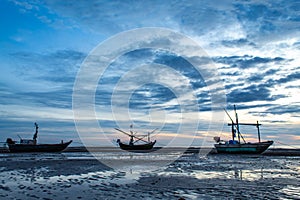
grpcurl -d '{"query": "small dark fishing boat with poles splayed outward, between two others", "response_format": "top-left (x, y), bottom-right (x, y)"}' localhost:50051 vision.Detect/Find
top-left (115, 125), bottom-right (156, 151)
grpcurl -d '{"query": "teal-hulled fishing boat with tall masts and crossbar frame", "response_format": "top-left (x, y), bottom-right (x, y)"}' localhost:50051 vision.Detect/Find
top-left (214, 105), bottom-right (273, 154)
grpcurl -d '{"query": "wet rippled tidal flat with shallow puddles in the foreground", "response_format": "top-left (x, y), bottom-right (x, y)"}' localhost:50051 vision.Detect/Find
top-left (0, 149), bottom-right (300, 200)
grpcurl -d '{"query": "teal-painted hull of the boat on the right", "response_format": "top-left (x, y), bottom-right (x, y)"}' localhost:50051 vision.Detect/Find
top-left (215, 141), bottom-right (273, 154)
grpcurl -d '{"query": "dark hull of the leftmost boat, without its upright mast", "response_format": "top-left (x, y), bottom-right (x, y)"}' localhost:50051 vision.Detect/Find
top-left (8, 140), bottom-right (72, 153)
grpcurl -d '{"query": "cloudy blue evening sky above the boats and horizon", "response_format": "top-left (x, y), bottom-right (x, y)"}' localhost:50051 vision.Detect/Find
top-left (0, 0), bottom-right (300, 147)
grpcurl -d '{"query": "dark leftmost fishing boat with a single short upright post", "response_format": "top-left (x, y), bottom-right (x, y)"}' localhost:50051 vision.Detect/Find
top-left (6, 123), bottom-right (72, 153)
